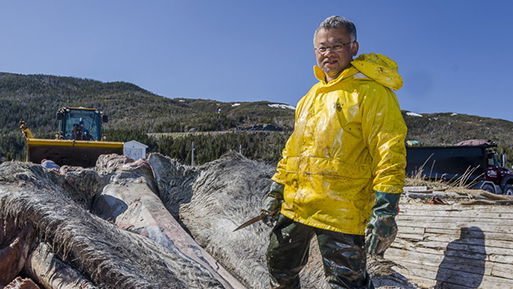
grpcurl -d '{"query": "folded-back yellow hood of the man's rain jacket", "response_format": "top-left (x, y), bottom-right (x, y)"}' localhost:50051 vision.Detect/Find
top-left (351, 53), bottom-right (403, 90)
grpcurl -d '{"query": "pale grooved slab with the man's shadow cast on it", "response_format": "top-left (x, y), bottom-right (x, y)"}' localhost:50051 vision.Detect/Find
top-left (385, 203), bottom-right (513, 289)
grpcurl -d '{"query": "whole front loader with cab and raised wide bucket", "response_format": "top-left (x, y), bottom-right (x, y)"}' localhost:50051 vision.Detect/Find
top-left (20, 107), bottom-right (123, 167)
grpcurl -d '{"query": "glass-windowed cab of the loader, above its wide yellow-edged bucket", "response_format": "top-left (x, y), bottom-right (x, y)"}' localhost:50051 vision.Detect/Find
top-left (56, 107), bottom-right (108, 141)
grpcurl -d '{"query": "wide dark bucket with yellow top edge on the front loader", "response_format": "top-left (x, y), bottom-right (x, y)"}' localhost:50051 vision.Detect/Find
top-left (27, 139), bottom-right (123, 168)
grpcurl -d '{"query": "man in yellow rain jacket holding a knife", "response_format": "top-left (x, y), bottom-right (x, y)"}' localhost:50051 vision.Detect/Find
top-left (262, 16), bottom-right (406, 288)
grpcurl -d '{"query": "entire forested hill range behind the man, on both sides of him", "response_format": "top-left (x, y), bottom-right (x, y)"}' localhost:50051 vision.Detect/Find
top-left (0, 73), bottom-right (513, 164)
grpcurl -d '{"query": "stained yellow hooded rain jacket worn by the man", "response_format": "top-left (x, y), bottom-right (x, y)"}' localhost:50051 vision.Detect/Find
top-left (272, 54), bottom-right (406, 235)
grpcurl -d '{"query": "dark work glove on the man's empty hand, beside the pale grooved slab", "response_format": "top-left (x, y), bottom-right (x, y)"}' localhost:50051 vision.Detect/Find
top-left (366, 191), bottom-right (401, 256)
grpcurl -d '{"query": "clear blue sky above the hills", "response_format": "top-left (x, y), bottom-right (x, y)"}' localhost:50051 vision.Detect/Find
top-left (0, 0), bottom-right (513, 121)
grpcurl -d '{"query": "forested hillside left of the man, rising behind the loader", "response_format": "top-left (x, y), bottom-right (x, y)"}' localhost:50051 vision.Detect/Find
top-left (0, 73), bottom-right (294, 134)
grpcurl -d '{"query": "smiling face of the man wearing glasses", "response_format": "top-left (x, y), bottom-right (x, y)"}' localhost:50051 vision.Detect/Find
top-left (314, 27), bottom-right (358, 82)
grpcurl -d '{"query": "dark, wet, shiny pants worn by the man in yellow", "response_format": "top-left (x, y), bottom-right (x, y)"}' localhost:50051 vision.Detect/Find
top-left (266, 214), bottom-right (374, 289)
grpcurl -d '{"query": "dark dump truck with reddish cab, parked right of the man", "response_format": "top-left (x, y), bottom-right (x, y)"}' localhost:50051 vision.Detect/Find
top-left (406, 140), bottom-right (513, 195)
